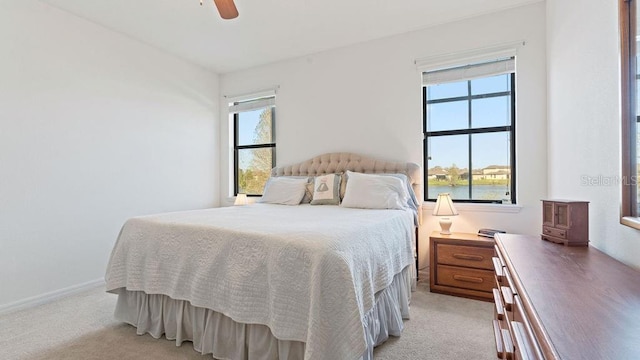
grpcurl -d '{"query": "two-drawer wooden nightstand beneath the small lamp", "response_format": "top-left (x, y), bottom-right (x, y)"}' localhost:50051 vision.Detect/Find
top-left (429, 231), bottom-right (496, 301)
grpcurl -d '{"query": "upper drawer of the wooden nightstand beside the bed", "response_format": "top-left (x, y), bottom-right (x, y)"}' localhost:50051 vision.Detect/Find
top-left (436, 244), bottom-right (494, 270)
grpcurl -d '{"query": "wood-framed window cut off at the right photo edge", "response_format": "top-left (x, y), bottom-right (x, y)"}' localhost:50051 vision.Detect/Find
top-left (619, 0), bottom-right (640, 229)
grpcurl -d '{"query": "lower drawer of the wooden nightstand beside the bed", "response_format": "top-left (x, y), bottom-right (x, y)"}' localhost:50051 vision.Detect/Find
top-left (436, 265), bottom-right (496, 294)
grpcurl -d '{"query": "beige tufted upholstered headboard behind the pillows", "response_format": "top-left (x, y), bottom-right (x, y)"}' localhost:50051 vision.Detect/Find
top-left (271, 152), bottom-right (423, 223)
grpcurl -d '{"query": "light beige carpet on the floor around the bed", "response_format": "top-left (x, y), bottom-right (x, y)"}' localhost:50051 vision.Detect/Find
top-left (0, 277), bottom-right (496, 360)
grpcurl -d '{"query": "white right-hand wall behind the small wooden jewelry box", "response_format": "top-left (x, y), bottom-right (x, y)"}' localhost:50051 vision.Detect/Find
top-left (546, 0), bottom-right (640, 268)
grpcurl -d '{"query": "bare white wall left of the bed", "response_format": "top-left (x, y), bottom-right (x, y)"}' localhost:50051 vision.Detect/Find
top-left (0, 0), bottom-right (219, 309)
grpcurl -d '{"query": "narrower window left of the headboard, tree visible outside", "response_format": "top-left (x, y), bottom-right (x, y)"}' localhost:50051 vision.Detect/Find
top-left (229, 96), bottom-right (276, 196)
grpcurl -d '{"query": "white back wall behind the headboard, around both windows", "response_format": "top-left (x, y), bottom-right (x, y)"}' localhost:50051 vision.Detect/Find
top-left (220, 3), bottom-right (547, 264)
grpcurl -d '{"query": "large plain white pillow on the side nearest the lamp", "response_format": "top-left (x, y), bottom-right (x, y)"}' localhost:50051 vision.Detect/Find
top-left (342, 171), bottom-right (409, 209)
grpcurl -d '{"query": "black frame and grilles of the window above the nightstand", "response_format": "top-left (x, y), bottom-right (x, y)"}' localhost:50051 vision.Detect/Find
top-left (422, 71), bottom-right (516, 205)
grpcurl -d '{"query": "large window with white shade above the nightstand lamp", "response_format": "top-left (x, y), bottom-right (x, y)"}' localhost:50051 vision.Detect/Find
top-left (422, 57), bottom-right (516, 203)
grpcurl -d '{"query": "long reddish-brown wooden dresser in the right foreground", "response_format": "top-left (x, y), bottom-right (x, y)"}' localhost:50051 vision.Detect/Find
top-left (494, 234), bottom-right (640, 360)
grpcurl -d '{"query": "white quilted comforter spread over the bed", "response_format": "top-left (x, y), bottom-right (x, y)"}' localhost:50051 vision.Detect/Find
top-left (106, 204), bottom-right (413, 359)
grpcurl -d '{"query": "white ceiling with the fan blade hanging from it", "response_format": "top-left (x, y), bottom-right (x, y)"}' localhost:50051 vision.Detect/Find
top-left (41, 0), bottom-right (543, 73)
